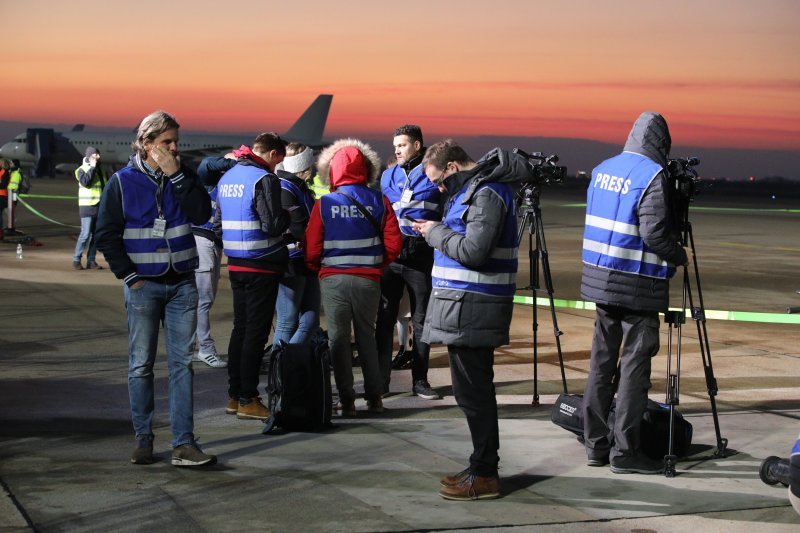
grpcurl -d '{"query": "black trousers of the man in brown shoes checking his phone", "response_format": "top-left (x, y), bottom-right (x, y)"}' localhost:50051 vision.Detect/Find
top-left (447, 344), bottom-right (500, 477)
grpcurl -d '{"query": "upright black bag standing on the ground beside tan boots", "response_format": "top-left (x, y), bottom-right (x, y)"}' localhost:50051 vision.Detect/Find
top-left (262, 342), bottom-right (333, 434)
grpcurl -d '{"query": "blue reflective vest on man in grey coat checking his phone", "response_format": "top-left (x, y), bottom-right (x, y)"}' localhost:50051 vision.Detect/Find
top-left (431, 179), bottom-right (517, 296)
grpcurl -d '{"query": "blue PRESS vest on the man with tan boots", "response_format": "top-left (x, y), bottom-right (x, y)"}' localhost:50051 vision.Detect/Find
top-left (217, 164), bottom-right (284, 259)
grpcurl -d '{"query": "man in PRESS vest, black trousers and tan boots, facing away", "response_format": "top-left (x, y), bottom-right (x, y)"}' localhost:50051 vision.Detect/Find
top-left (213, 132), bottom-right (290, 420)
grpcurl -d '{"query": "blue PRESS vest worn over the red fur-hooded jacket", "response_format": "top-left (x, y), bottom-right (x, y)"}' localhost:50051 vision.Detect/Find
top-left (319, 185), bottom-right (386, 269)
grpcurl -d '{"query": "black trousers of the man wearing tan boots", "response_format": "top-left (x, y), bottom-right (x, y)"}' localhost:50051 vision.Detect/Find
top-left (228, 271), bottom-right (281, 399)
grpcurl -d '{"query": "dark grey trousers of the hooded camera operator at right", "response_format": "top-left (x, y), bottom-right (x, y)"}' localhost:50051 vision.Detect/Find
top-left (583, 305), bottom-right (659, 459)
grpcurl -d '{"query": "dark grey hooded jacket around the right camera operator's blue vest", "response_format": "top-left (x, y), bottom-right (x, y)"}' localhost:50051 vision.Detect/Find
top-left (581, 111), bottom-right (687, 311)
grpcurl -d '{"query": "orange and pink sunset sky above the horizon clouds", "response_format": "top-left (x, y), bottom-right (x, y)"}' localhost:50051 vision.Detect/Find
top-left (0, 0), bottom-right (800, 150)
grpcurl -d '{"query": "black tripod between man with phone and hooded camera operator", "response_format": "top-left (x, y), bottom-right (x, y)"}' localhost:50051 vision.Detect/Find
top-left (517, 185), bottom-right (567, 407)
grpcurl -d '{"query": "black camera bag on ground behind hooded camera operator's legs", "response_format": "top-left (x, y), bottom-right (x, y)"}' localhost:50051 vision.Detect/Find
top-left (550, 394), bottom-right (692, 460)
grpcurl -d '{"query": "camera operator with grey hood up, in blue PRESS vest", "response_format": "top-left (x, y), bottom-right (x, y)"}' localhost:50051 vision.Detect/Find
top-left (581, 112), bottom-right (688, 474)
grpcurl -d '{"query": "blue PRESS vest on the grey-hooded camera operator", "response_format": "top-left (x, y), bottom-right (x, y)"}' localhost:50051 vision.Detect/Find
top-left (583, 152), bottom-right (675, 279)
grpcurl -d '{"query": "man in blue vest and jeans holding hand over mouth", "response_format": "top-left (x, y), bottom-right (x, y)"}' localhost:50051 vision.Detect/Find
top-left (96, 111), bottom-right (216, 466)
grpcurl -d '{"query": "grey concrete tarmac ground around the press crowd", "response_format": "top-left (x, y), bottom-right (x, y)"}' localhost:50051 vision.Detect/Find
top-left (0, 176), bottom-right (800, 532)
